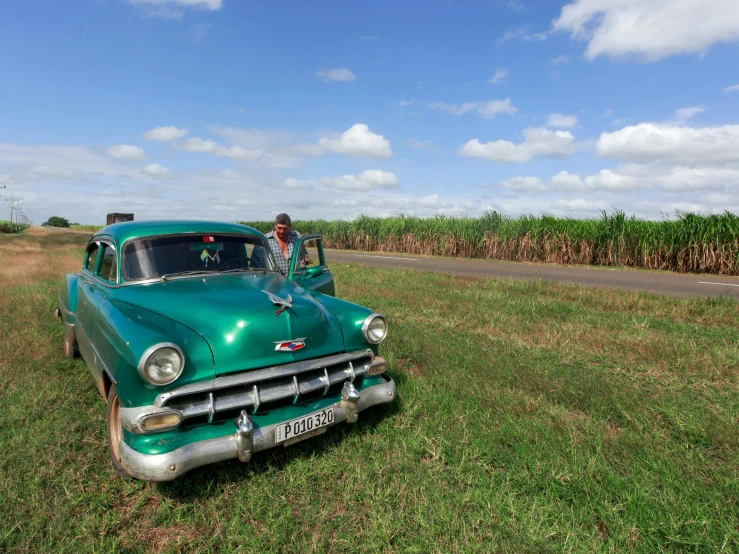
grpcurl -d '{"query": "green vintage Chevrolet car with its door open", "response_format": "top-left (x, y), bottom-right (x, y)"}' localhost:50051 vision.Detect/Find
top-left (56, 221), bottom-right (395, 481)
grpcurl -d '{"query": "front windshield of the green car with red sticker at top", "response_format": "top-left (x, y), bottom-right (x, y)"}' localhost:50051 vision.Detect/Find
top-left (122, 234), bottom-right (274, 281)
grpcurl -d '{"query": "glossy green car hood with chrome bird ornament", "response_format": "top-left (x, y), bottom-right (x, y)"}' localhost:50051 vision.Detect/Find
top-left (116, 272), bottom-right (344, 375)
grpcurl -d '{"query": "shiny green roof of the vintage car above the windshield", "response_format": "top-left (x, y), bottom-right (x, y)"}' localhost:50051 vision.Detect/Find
top-left (93, 220), bottom-right (263, 244)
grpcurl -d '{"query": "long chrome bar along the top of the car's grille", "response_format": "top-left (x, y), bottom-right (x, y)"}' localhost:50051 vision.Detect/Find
top-left (154, 348), bottom-right (375, 407)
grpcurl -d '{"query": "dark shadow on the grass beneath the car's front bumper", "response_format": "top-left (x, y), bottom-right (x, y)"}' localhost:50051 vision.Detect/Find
top-left (156, 374), bottom-right (407, 501)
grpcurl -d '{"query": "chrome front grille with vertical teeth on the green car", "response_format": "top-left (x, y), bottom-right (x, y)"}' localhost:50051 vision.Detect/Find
top-left (154, 349), bottom-right (384, 422)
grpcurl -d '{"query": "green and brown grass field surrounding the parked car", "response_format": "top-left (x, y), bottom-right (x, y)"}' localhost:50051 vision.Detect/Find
top-left (0, 229), bottom-right (739, 553)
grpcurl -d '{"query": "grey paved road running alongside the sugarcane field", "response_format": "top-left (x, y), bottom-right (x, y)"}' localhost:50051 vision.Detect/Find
top-left (326, 250), bottom-right (739, 299)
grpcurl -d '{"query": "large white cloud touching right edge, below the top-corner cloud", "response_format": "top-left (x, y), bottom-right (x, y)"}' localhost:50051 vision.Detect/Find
top-left (596, 123), bottom-right (739, 165)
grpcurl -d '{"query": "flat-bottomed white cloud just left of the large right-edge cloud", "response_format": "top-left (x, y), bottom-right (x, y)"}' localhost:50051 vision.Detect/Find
top-left (457, 127), bottom-right (575, 163)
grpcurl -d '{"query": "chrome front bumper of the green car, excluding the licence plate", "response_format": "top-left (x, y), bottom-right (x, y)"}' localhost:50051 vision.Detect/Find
top-left (119, 375), bottom-right (395, 481)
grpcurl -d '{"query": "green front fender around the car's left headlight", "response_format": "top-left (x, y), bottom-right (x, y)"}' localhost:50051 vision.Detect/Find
top-left (92, 299), bottom-right (216, 407)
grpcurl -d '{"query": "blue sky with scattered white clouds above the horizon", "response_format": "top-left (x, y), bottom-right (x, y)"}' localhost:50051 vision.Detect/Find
top-left (0, 0), bottom-right (739, 223)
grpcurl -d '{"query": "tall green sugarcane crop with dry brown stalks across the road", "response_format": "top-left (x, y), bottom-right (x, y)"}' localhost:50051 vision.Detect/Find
top-left (244, 211), bottom-right (739, 275)
